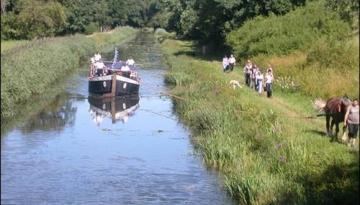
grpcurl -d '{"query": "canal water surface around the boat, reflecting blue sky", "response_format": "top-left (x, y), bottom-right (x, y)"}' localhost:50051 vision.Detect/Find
top-left (1, 33), bottom-right (234, 205)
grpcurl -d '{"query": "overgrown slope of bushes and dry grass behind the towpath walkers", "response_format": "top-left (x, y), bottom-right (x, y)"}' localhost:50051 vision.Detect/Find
top-left (227, 1), bottom-right (359, 98)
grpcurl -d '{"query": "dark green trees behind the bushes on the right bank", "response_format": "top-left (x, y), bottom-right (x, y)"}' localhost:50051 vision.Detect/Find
top-left (161, 0), bottom-right (305, 44)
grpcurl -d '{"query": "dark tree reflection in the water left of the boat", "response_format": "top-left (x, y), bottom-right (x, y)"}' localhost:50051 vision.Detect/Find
top-left (21, 94), bottom-right (77, 134)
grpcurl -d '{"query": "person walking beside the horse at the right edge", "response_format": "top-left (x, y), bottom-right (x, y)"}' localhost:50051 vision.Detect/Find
top-left (344, 99), bottom-right (359, 146)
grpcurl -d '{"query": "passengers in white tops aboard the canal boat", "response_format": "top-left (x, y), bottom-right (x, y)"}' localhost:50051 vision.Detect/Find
top-left (90, 53), bottom-right (135, 77)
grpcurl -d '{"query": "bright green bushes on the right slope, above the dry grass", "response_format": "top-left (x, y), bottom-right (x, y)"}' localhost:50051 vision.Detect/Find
top-left (227, 1), bottom-right (350, 56)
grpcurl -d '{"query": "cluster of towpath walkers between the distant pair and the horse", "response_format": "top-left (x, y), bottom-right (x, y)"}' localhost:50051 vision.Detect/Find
top-left (244, 59), bottom-right (274, 98)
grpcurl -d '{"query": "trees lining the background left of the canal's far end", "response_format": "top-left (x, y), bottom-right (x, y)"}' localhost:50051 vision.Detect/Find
top-left (1, 0), bottom-right (160, 40)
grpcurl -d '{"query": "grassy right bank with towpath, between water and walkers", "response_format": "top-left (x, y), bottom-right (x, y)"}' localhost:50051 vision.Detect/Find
top-left (162, 40), bottom-right (359, 204)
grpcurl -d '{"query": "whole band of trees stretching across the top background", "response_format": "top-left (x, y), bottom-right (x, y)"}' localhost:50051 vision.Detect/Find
top-left (1, 0), bottom-right (359, 44)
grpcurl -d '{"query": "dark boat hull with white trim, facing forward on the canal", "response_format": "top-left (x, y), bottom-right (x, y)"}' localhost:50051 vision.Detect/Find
top-left (89, 74), bottom-right (140, 97)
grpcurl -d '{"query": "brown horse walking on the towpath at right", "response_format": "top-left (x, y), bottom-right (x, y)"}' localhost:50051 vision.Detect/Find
top-left (318, 97), bottom-right (351, 140)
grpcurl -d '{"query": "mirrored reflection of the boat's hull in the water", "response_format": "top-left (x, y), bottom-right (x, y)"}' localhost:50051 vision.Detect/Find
top-left (88, 95), bottom-right (139, 125)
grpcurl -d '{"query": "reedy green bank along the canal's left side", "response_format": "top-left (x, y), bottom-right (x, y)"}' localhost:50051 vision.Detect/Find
top-left (1, 27), bottom-right (137, 119)
